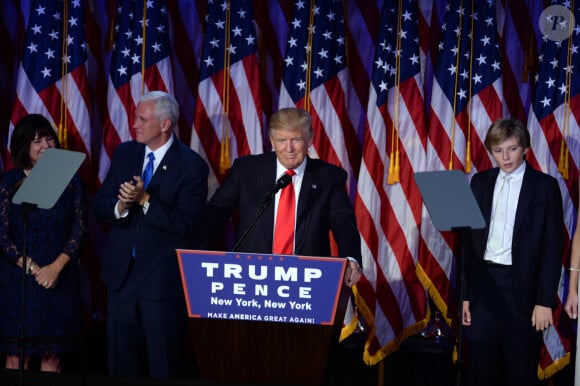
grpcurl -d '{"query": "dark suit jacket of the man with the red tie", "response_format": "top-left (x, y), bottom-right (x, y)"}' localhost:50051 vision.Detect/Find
top-left (203, 152), bottom-right (361, 263)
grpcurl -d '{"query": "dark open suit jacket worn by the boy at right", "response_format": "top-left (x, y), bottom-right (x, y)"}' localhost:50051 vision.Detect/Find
top-left (466, 165), bottom-right (564, 316)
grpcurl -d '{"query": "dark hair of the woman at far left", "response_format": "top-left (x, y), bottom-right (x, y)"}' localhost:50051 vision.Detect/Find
top-left (10, 114), bottom-right (60, 169)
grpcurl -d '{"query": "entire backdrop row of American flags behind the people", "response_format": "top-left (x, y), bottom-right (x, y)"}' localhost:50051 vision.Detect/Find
top-left (0, 0), bottom-right (580, 378)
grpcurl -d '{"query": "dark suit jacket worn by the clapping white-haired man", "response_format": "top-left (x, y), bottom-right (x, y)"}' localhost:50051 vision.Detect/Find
top-left (92, 139), bottom-right (208, 300)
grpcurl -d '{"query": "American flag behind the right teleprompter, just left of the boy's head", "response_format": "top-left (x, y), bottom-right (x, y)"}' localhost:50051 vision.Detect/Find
top-left (420, 1), bottom-right (503, 332)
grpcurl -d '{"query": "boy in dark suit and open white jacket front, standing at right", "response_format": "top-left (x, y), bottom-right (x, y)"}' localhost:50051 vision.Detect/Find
top-left (462, 119), bottom-right (563, 385)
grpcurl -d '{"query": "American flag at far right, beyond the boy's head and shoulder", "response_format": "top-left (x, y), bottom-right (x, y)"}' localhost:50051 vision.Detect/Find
top-left (526, 2), bottom-right (580, 378)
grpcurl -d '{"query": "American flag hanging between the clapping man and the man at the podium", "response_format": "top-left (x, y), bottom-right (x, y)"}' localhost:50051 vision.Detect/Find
top-left (191, 0), bottom-right (265, 194)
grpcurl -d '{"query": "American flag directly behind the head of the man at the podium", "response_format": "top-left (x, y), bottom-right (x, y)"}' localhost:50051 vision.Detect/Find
top-left (278, 0), bottom-right (362, 192)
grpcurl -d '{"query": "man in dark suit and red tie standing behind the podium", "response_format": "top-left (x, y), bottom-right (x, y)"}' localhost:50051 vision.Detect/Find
top-left (203, 108), bottom-right (361, 286)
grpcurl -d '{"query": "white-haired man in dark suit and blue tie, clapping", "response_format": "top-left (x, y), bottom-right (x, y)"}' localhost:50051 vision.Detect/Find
top-left (92, 91), bottom-right (208, 378)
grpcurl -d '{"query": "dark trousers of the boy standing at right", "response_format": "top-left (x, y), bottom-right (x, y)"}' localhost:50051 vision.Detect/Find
top-left (465, 266), bottom-right (542, 386)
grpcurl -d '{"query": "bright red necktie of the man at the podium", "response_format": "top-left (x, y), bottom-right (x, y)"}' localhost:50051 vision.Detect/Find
top-left (272, 169), bottom-right (296, 255)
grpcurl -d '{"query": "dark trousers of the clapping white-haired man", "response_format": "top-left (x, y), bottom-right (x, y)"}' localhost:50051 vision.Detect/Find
top-left (107, 272), bottom-right (187, 379)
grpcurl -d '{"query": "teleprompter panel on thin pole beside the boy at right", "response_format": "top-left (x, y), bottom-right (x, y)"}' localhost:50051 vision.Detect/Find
top-left (415, 170), bottom-right (485, 386)
